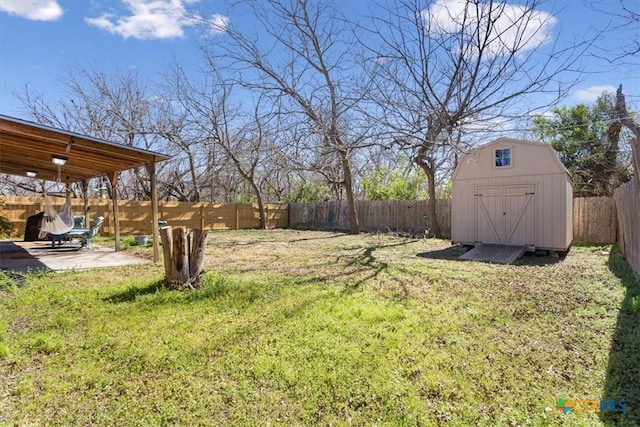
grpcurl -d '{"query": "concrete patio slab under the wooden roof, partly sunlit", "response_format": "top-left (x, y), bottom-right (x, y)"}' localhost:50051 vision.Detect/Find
top-left (0, 241), bottom-right (150, 273)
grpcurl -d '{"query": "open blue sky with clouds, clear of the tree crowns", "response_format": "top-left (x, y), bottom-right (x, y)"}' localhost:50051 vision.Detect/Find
top-left (0, 0), bottom-right (640, 117)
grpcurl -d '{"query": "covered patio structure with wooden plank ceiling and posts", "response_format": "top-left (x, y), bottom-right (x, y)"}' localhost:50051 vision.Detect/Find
top-left (0, 115), bottom-right (169, 262)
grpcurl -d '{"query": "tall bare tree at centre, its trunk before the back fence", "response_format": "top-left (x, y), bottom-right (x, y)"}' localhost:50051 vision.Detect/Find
top-left (202, 0), bottom-right (376, 234)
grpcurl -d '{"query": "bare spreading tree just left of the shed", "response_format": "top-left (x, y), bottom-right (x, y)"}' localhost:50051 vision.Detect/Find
top-left (363, 0), bottom-right (584, 236)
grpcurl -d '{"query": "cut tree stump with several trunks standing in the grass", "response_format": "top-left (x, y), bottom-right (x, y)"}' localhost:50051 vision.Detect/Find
top-left (160, 227), bottom-right (208, 289)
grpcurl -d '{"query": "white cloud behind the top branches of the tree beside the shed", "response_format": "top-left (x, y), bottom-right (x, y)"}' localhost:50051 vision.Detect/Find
top-left (422, 0), bottom-right (557, 56)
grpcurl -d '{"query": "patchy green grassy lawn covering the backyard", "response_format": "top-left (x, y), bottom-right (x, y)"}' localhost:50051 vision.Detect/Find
top-left (0, 230), bottom-right (640, 426)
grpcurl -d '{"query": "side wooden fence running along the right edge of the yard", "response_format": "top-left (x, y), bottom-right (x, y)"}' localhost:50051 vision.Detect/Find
top-left (614, 179), bottom-right (640, 275)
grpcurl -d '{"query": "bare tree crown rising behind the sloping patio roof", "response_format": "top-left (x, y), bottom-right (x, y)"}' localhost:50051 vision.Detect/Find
top-left (16, 67), bottom-right (176, 200)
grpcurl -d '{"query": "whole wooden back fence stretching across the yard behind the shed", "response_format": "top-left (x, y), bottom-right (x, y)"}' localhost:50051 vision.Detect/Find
top-left (0, 194), bottom-right (620, 244)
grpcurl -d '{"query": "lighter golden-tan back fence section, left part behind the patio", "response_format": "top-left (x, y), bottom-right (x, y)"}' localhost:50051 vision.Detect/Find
top-left (0, 196), bottom-right (289, 236)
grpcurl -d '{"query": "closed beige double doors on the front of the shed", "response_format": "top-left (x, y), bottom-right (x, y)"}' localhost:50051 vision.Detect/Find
top-left (475, 184), bottom-right (536, 245)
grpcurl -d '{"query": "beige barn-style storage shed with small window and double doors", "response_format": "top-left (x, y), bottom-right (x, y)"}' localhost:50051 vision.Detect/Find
top-left (451, 138), bottom-right (573, 252)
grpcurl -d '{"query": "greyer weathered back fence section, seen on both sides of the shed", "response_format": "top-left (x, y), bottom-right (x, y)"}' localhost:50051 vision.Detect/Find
top-left (289, 197), bottom-right (617, 243)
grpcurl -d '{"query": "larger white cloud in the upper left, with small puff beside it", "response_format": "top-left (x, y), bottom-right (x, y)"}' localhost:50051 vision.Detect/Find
top-left (85, 0), bottom-right (228, 40)
